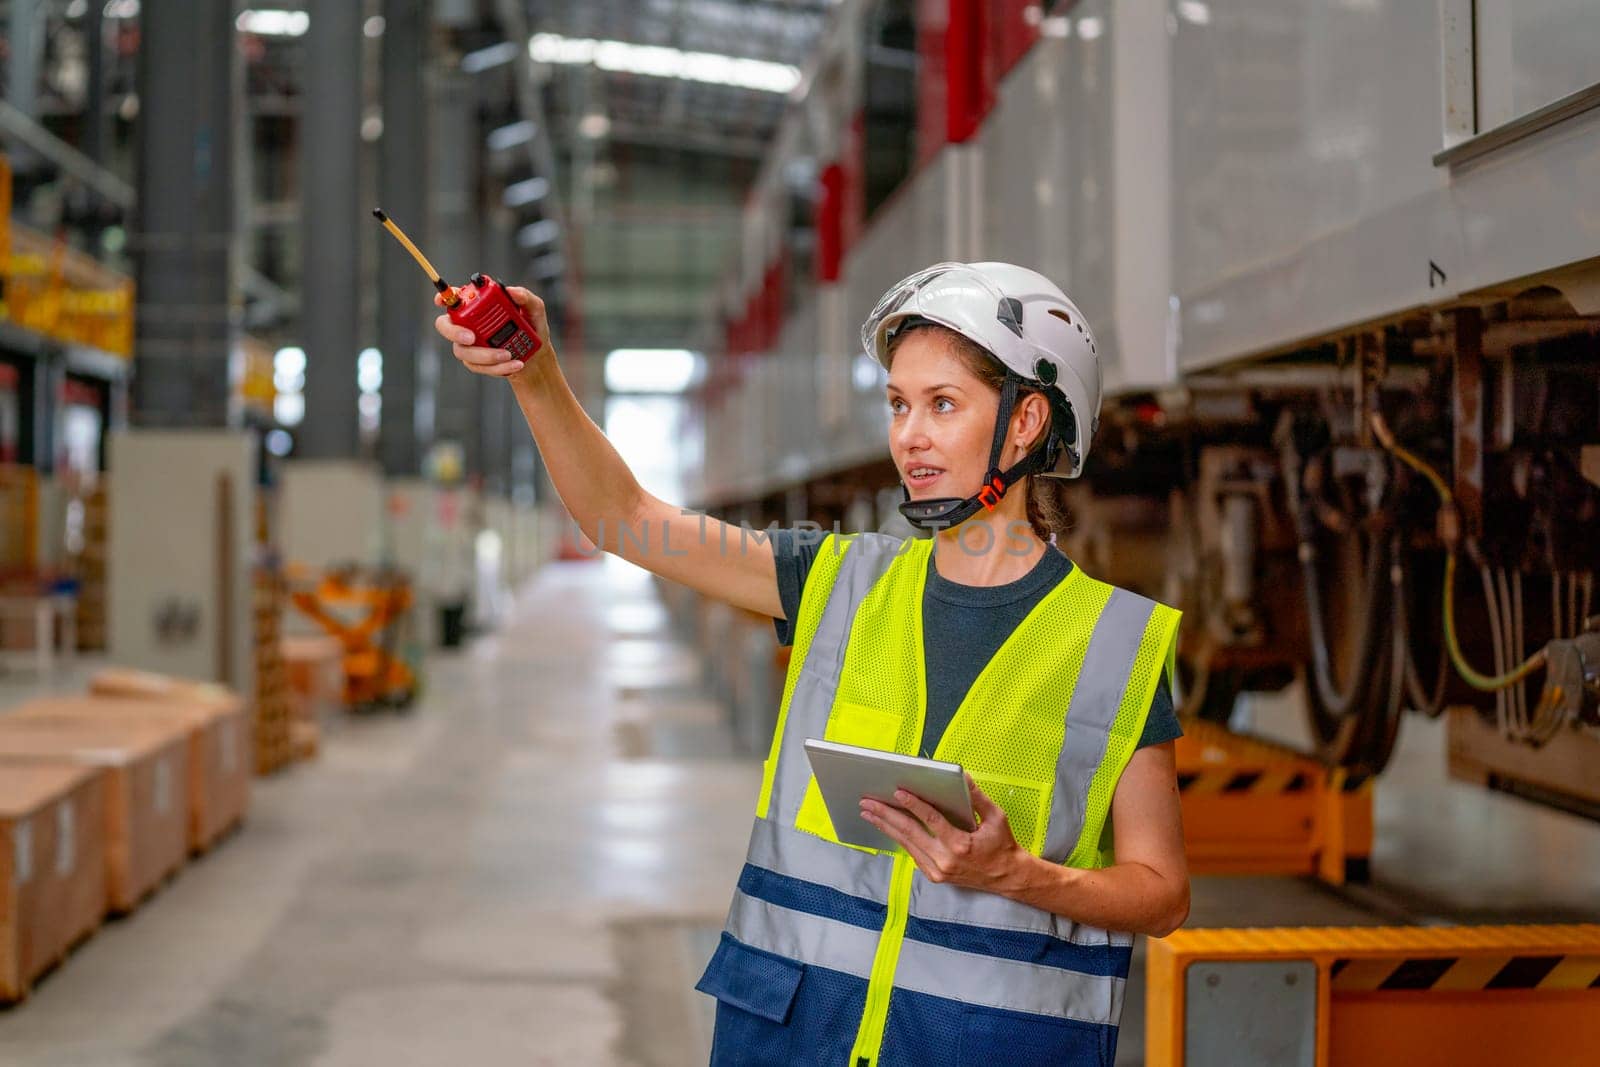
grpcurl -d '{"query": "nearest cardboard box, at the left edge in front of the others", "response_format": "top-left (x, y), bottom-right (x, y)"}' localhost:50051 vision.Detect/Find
top-left (0, 763), bottom-right (107, 1003)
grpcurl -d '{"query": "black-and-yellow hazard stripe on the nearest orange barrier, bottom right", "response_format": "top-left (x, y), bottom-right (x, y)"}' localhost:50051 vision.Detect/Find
top-left (1330, 955), bottom-right (1600, 993)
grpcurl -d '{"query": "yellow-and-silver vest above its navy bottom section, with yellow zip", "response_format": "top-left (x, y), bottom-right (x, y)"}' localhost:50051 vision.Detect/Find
top-left (728, 534), bottom-right (1178, 1067)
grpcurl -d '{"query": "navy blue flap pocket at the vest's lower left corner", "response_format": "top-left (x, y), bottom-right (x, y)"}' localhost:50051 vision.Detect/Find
top-left (694, 933), bottom-right (805, 1067)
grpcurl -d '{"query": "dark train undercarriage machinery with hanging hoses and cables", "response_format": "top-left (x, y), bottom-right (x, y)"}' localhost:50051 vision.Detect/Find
top-left (1126, 326), bottom-right (1600, 813)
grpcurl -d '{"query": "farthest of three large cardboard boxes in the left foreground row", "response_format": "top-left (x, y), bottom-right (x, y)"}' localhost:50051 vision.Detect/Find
top-left (13, 696), bottom-right (254, 854)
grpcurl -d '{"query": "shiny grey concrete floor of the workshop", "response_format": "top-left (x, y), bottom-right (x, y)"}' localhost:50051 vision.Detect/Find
top-left (0, 561), bottom-right (1600, 1067)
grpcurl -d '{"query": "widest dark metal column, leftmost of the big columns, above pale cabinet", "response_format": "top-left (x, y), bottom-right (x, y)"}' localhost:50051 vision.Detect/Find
top-left (130, 3), bottom-right (238, 427)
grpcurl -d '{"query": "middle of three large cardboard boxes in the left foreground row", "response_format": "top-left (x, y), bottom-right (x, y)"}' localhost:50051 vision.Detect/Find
top-left (0, 715), bottom-right (189, 913)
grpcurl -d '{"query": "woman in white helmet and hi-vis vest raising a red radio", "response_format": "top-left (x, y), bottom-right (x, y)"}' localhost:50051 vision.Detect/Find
top-left (438, 264), bottom-right (1189, 1067)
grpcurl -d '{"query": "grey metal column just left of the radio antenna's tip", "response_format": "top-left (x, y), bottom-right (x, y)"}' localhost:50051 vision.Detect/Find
top-left (297, 0), bottom-right (371, 459)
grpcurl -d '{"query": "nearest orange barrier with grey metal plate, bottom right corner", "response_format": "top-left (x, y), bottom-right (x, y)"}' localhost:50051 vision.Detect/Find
top-left (1146, 925), bottom-right (1600, 1067)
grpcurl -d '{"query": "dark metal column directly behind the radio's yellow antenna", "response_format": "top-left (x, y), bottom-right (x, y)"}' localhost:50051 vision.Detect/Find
top-left (378, 0), bottom-right (434, 478)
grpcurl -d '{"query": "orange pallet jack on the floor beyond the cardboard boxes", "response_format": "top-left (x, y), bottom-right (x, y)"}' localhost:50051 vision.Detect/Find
top-left (290, 568), bottom-right (419, 712)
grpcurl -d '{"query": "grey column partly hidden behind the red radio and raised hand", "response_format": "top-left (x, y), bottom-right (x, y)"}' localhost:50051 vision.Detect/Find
top-left (427, 69), bottom-right (476, 478)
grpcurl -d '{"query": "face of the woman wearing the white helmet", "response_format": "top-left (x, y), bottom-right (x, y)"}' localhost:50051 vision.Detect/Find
top-left (888, 330), bottom-right (1000, 501)
